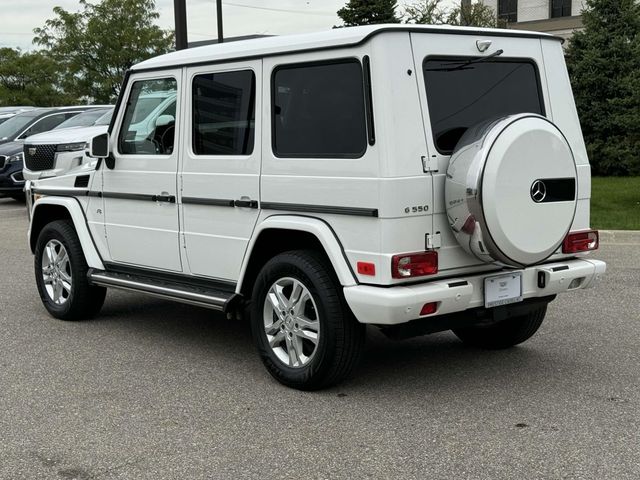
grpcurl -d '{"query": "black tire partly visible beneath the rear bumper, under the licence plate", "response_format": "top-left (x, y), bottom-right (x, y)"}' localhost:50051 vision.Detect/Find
top-left (453, 305), bottom-right (547, 350)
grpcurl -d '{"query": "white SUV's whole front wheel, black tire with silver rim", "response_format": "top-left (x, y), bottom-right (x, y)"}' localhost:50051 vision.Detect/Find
top-left (35, 220), bottom-right (107, 320)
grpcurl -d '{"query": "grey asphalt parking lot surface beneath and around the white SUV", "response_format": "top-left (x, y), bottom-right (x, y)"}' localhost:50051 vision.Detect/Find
top-left (0, 199), bottom-right (640, 479)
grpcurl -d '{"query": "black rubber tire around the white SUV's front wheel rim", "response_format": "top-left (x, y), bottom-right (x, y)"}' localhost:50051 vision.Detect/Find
top-left (34, 220), bottom-right (107, 320)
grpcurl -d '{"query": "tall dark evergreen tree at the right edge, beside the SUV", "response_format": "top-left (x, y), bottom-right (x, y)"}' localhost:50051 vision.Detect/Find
top-left (566, 0), bottom-right (640, 175)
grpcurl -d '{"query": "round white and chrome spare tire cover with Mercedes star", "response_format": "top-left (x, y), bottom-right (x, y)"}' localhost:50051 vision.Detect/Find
top-left (445, 113), bottom-right (577, 267)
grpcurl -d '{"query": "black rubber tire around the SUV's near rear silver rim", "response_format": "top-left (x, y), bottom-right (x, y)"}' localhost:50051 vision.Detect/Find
top-left (251, 250), bottom-right (365, 390)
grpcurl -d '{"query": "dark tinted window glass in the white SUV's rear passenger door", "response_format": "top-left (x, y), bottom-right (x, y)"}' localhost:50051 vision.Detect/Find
top-left (193, 70), bottom-right (256, 155)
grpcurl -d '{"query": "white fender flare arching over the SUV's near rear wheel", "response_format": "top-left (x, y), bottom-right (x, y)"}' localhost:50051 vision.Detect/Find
top-left (237, 215), bottom-right (358, 292)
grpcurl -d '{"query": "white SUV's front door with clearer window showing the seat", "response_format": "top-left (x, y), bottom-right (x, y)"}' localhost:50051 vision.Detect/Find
top-left (102, 70), bottom-right (182, 272)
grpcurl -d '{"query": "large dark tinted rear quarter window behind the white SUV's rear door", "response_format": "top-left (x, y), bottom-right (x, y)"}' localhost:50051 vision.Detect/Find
top-left (272, 60), bottom-right (367, 157)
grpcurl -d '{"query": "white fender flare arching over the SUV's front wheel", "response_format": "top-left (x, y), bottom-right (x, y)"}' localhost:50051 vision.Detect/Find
top-left (28, 196), bottom-right (104, 270)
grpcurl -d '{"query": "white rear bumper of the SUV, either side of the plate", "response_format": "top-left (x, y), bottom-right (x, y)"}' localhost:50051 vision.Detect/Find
top-left (344, 259), bottom-right (607, 325)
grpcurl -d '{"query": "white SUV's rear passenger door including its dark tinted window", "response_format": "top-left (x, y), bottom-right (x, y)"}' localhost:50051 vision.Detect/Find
top-left (180, 60), bottom-right (262, 282)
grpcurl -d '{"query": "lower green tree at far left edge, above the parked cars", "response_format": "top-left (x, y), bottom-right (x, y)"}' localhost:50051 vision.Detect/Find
top-left (0, 48), bottom-right (77, 107)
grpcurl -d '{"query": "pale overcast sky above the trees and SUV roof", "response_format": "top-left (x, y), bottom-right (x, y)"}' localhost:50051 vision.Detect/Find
top-left (0, 0), bottom-right (453, 50)
